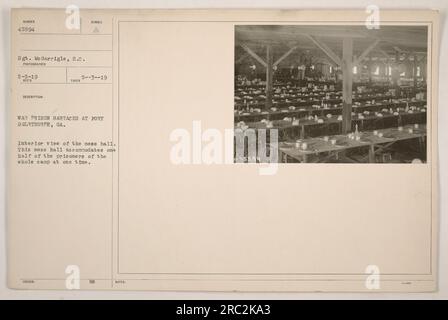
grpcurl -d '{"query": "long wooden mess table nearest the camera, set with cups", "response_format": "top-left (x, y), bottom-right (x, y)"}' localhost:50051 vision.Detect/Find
top-left (278, 125), bottom-right (426, 163)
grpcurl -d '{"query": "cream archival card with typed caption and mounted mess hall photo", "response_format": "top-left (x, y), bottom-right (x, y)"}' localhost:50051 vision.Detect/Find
top-left (7, 7), bottom-right (439, 292)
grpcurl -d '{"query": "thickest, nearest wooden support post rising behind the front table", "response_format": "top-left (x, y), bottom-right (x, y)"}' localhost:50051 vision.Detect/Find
top-left (342, 38), bottom-right (353, 133)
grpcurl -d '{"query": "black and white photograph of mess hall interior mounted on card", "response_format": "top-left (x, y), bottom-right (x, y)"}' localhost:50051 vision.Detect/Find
top-left (234, 25), bottom-right (430, 164)
